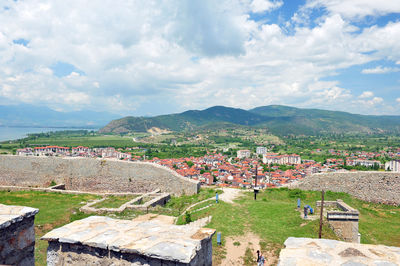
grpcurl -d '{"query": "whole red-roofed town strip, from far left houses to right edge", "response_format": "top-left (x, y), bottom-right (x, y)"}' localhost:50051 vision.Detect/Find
top-left (16, 146), bottom-right (400, 188)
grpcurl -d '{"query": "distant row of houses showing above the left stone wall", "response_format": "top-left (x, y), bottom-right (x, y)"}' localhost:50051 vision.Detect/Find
top-left (16, 146), bottom-right (132, 160)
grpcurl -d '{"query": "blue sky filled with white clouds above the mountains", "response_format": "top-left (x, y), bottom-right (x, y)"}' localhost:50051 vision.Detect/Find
top-left (0, 0), bottom-right (400, 116)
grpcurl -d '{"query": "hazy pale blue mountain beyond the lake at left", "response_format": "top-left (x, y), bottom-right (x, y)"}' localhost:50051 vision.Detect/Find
top-left (0, 104), bottom-right (119, 128)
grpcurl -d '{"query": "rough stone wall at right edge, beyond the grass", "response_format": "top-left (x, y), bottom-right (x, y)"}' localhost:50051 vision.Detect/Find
top-left (292, 172), bottom-right (400, 205)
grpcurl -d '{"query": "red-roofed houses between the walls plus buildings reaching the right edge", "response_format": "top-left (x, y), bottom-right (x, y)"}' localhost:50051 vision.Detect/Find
top-left (143, 147), bottom-right (400, 188)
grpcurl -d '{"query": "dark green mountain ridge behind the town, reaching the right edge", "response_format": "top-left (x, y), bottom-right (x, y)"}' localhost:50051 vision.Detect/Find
top-left (100, 105), bottom-right (400, 135)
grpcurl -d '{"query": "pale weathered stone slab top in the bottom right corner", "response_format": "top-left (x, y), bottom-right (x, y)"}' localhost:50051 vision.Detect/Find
top-left (278, 237), bottom-right (400, 266)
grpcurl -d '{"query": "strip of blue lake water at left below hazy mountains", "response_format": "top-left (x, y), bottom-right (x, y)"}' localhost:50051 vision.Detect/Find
top-left (0, 126), bottom-right (97, 141)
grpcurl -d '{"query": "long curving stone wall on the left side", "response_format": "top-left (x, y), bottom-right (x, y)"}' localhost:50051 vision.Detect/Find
top-left (0, 155), bottom-right (200, 195)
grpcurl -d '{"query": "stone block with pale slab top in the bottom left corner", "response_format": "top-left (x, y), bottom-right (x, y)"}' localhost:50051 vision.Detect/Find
top-left (0, 204), bottom-right (38, 266)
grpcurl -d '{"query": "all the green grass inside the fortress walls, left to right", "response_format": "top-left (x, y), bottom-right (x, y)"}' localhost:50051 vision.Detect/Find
top-left (0, 189), bottom-right (400, 265)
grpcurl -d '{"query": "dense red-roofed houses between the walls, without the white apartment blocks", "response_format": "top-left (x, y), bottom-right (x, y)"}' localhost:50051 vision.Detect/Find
top-left (142, 153), bottom-right (334, 188)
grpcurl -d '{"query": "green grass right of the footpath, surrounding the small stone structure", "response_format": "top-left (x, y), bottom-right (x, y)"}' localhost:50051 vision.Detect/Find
top-left (203, 189), bottom-right (400, 259)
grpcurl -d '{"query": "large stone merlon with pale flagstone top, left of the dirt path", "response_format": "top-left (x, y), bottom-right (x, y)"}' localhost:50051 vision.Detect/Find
top-left (42, 216), bottom-right (215, 265)
